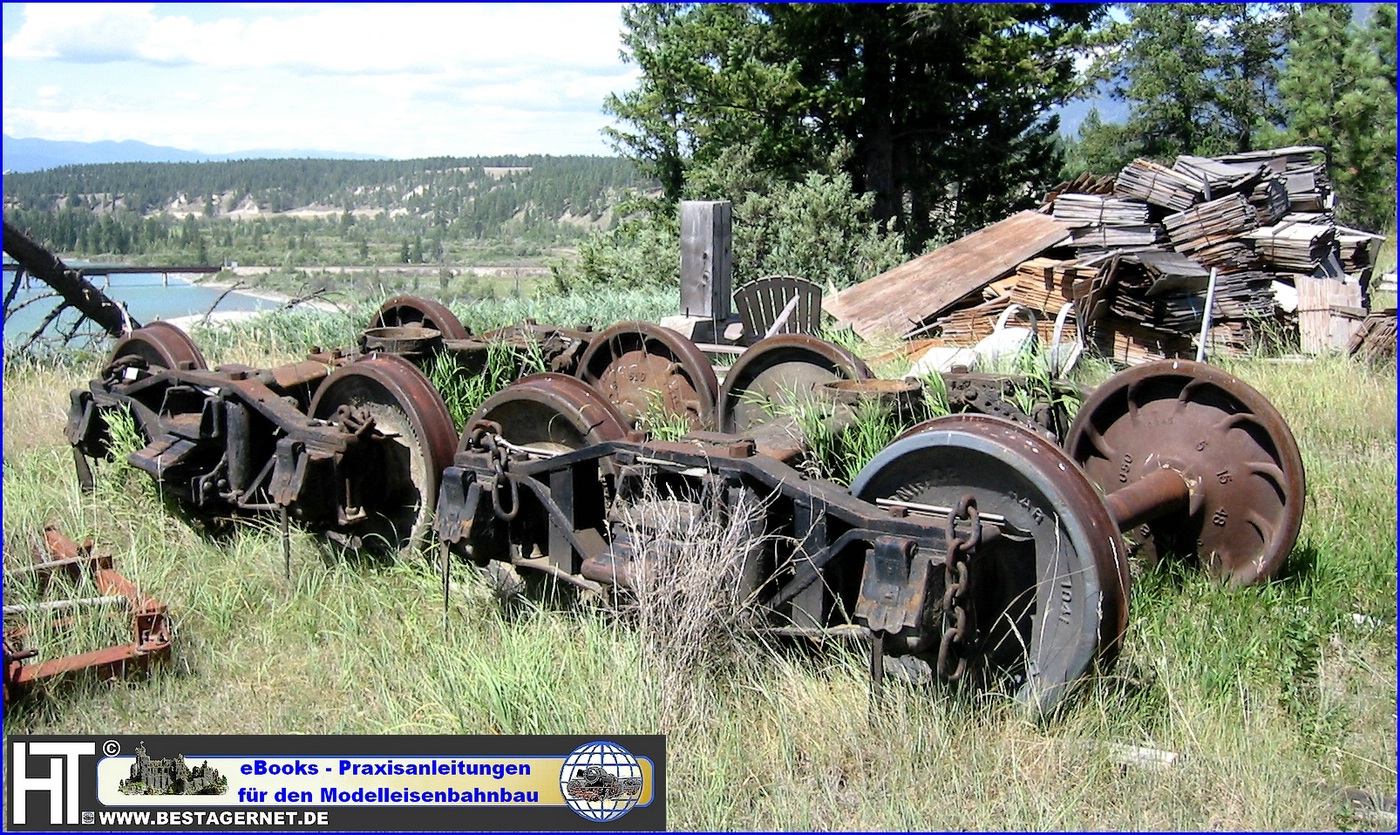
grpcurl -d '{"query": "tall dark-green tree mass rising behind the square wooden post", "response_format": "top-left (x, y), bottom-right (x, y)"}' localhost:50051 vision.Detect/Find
top-left (606, 3), bottom-right (1100, 249)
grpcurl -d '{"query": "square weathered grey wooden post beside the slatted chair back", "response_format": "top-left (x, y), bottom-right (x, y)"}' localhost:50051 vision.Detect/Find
top-left (680, 200), bottom-right (734, 321)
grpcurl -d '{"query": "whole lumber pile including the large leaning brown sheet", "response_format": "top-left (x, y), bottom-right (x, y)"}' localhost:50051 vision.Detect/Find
top-left (823, 146), bottom-right (1380, 363)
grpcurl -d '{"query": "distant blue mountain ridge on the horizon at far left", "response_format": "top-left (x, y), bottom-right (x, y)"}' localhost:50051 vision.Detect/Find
top-left (0, 134), bottom-right (384, 172)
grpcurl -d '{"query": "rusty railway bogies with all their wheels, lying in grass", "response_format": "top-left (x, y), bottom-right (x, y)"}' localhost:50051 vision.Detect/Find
top-left (66, 297), bottom-right (1303, 710)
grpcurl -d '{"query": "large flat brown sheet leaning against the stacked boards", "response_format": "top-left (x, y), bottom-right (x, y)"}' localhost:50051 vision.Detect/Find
top-left (822, 212), bottom-right (1070, 339)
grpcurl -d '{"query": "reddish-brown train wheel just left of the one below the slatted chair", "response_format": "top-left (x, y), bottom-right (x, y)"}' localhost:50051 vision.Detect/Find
top-left (575, 322), bottom-right (720, 430)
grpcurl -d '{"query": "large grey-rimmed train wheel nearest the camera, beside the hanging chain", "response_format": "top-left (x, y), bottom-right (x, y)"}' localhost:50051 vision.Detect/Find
top-left (851, 415), bottom-right (1128, 712)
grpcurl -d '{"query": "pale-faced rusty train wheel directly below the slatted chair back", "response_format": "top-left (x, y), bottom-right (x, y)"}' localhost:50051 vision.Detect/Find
top-left (720, 333), bottom-right (872, 434)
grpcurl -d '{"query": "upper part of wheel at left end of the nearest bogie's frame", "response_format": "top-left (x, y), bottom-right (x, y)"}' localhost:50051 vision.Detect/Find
top-left (458, 373), bottom-right (627, 453)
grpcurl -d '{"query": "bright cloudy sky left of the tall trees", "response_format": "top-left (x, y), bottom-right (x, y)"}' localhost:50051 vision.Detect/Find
top-left (3, 3), bottom-right (637, 158)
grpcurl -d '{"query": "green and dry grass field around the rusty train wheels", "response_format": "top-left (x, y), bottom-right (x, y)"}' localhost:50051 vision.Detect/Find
top-left (4, 294), bottom-right (1397, 829)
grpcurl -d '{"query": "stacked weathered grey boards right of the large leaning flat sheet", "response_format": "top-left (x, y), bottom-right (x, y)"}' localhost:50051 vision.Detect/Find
top-left (1050, 146), bottom-right (1380, 361)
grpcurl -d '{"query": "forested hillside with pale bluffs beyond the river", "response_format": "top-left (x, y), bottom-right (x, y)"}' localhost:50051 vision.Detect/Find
top-left (4, 156), bottom-right (650, 265)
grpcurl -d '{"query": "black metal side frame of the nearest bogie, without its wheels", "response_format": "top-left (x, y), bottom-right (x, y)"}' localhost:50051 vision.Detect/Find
top-left (434, 433), bottom-right (1000, 651)
